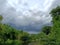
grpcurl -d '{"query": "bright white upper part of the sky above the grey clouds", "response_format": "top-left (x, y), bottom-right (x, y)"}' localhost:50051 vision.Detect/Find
top-left (7, 0), bottom-right (54, 11)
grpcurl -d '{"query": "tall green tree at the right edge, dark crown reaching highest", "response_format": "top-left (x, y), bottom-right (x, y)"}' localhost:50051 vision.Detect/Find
top-left (50, 6), bottom-right (60, 45)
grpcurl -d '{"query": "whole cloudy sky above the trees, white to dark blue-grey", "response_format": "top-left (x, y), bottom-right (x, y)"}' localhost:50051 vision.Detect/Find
top-left (0, 0), bottom-right (60, 33)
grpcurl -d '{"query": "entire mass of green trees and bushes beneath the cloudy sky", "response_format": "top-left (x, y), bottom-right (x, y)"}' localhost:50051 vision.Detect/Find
top-left (0, 6), bottom-right (60, 45)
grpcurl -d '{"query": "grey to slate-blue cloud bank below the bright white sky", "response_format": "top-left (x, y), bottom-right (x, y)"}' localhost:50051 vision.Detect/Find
top-left (0, 0), bottom-right (60, 32)
